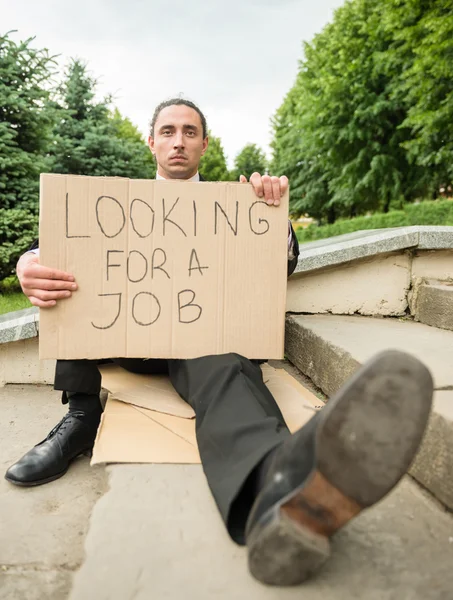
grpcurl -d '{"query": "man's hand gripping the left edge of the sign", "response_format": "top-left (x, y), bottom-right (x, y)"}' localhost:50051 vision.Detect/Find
top-left (16, 252), bottom-right (77, 308)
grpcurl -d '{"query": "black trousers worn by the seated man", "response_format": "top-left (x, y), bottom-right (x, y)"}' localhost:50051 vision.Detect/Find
top-left (54, 354), bottom-right (290, 543)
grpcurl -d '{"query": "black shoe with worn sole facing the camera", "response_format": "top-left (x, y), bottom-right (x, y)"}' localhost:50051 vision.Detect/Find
top-left (246, 351), bottom-right (433, 585)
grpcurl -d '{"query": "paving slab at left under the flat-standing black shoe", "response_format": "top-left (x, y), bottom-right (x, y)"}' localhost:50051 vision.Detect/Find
top-left (0, 385), bottom-right (107, 600)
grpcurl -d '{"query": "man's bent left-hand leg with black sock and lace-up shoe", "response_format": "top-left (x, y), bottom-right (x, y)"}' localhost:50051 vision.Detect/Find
top-left (5, 360), bottom-right (102, 486)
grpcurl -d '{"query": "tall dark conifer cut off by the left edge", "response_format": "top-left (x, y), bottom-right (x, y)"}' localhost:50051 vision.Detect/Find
top-left (0, 33), bottom-right (54, 211)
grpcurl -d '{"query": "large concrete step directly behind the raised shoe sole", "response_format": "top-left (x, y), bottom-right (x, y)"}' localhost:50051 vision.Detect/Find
top-left (286, 315), bottom-right (453, 510)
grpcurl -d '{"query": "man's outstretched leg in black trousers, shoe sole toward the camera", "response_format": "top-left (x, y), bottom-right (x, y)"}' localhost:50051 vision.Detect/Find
top-left (170, 351), bottom-right (433, 585)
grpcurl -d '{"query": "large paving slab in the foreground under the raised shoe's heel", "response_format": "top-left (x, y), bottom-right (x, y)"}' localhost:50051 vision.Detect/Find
top-left (70, 465), bottom-right (453, 600)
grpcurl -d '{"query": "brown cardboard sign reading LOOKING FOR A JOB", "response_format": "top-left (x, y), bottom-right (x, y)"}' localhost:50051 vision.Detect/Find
top-left (39, 175), bottom-right (288, 359)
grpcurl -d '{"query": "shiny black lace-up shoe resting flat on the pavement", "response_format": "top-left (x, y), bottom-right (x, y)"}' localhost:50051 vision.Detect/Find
top-left (5, 411), bottom-right (100, 486)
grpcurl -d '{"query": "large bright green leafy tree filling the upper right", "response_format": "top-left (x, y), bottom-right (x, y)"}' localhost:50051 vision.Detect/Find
top-left (272, 0), bottom-right (453, 222)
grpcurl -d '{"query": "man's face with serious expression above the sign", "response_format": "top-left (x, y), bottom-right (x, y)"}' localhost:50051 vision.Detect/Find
top-left (148, 104), bottom-right (208, 179)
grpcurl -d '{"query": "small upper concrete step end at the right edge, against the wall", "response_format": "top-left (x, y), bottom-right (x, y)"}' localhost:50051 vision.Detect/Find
top-left (410, 281), bottom-right (453, 331)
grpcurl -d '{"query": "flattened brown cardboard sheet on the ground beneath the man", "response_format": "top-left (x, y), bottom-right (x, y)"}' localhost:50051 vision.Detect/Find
top-left (91, 364), bottom-right (322, 465)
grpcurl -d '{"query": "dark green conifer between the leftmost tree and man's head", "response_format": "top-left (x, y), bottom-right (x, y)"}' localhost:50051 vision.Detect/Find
top-left (50, 60), bottom-right (155, 178)
